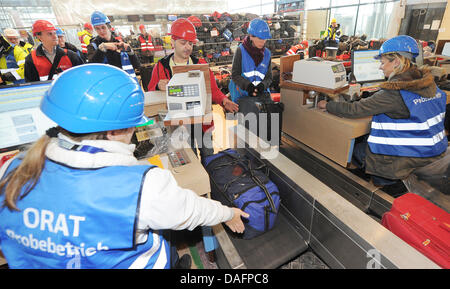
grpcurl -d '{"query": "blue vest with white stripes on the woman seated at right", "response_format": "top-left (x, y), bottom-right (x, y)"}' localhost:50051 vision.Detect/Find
top-left (367, 89), bottom-right (447, 157)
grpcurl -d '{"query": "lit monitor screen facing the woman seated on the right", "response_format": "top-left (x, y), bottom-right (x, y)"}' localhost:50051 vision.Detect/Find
top-left (352, 50), bottom-right (384, 82)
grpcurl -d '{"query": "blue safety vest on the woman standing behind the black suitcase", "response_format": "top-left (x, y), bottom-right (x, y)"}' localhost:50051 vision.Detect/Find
top-left (228, 44), bottom-right (271, 102)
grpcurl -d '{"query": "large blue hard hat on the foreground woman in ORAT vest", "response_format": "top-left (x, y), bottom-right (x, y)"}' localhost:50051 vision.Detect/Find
top-left (40, 63), bottom-right (148, 133)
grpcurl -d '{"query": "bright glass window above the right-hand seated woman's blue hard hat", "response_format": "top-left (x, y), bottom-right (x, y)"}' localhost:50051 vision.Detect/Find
top-left (355, 2), bottom-right (394, 39)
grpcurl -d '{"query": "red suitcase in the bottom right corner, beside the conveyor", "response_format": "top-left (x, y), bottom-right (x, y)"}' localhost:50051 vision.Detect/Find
top-left (382, 193), bottom-right (450, 269)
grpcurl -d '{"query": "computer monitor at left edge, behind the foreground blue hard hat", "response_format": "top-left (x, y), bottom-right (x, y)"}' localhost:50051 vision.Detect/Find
top-left (0, 82), bottom-right (56, 153)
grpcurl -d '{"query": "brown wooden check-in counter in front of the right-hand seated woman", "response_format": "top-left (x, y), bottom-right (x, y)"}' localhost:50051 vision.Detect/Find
top-left (280, 55), bottom-right (372, 167)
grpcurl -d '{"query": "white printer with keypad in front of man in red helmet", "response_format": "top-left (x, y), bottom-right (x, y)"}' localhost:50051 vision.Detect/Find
top-left (166, 70), bottom-right (207, 118)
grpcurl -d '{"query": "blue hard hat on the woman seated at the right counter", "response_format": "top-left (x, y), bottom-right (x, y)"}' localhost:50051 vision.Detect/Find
top-left (375, 35), bottom-right (419, 59)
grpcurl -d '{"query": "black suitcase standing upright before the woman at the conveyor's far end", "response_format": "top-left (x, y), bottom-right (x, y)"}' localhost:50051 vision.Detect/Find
top-left (238, 92), bottom-right (284, 146)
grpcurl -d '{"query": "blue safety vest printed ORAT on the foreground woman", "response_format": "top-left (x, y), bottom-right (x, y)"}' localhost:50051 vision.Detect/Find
top-left (0, 155), bottom-right (170, 269)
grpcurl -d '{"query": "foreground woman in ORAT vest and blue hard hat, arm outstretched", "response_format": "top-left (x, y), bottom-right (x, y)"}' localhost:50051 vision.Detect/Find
top-left (0, 64), bottom-right (248, 268)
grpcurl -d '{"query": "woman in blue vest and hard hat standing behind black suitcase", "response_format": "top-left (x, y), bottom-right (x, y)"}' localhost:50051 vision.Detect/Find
top-left (228, 18), bottom-right (272, 103)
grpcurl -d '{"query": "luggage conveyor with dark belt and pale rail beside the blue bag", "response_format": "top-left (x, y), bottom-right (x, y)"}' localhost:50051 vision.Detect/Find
top-left (212, 125), bottom-right (439, 269)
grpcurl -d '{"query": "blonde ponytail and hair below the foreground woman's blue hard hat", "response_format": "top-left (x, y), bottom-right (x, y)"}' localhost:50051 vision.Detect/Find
top-left (0, 127), bottom-right (106, 211)
